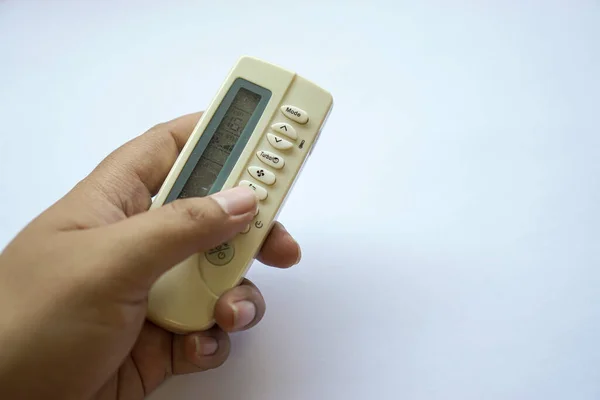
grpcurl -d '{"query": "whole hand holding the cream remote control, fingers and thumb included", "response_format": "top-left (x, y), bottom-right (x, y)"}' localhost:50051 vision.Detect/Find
top-left (0, 113), bottom-right (300, 400)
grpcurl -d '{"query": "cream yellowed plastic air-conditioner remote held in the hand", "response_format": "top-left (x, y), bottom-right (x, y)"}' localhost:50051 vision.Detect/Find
top-left (148, 57), bottom-right (333, 333)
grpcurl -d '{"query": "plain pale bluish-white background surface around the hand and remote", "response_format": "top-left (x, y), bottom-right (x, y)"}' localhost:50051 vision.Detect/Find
top-left (0, 0), bottom-right (600, 400)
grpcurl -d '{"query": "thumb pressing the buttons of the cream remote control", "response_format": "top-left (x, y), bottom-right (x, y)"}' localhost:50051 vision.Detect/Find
top-left (101, 187), bottom-right (258, 284)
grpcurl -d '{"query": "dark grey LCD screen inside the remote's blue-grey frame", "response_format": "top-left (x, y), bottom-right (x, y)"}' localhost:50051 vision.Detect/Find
top-left (179, 88), bottom-right (261, 198)
